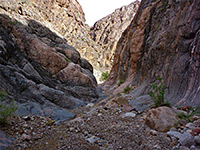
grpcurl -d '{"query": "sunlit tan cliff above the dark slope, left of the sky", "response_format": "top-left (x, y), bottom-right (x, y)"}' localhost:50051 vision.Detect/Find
top-left (0, 0), bottom-right (108, 79)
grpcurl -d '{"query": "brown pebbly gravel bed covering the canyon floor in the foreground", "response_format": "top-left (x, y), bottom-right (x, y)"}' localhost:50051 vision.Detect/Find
top-left (1, 95), bottom-right (173, 150)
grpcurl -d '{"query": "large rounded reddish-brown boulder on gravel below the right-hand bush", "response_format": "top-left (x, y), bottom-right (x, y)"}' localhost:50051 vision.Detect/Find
top-left (145, 106), bottom-right (178, 132)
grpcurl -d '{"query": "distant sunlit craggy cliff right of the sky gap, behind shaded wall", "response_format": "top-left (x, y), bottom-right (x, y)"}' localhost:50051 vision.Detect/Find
top-left (90, 1), bottom-right (140, 68)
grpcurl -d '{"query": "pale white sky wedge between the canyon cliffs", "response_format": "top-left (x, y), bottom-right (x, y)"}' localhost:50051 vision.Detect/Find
top-left (78, 0), bottom-right (138, 26)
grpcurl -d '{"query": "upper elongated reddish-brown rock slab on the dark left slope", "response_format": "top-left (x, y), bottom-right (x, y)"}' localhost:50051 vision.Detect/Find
top-left (18, 33), bottom-right (68, 74)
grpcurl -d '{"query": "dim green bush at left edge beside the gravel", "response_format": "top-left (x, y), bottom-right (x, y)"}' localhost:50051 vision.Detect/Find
top-left (0, 91), bottom-right (17, 124)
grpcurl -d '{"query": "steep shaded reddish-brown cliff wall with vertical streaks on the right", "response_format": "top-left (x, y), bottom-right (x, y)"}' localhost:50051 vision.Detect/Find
top-left (102, 0), bottom-right (200, 105)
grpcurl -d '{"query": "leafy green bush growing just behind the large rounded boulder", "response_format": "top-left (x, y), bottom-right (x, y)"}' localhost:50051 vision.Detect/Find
top-left (149, 77), bottom-right (170, 107)
